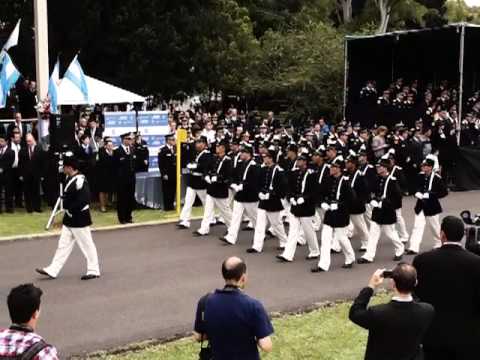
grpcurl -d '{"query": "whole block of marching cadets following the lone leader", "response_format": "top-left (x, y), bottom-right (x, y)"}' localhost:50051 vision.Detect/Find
top-left (172, 120), bottom-right (448, 272)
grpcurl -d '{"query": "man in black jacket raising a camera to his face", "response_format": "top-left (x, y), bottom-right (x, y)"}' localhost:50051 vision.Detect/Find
top-left (349, 264), bottom-right (436, 360)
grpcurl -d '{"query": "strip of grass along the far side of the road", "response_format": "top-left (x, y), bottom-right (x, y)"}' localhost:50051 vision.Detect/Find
top-left (0, 206), bottom-right (202, 238)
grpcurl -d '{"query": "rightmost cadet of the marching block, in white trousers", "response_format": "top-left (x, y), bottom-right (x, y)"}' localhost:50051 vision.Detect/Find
top-left (407, 156), bottom-right (448, 255)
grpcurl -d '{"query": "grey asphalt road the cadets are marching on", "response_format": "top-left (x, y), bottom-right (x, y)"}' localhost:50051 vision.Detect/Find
top-left (0, 192), bottom-right (480, 357)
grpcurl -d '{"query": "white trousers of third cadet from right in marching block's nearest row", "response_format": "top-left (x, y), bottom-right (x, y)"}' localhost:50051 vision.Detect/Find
top-left (318, 224), bottom-right (355, 271)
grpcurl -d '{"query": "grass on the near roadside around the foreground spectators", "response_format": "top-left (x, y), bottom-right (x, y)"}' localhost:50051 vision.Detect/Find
top-left (89, 294), bottom-right (389, 360)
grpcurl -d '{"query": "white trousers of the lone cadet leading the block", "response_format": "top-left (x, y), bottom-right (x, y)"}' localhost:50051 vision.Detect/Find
top-left (44, 225), bottom-right (100, 277)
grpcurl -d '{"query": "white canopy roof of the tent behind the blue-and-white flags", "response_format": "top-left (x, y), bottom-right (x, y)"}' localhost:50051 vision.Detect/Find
top-left (57, 76), bottom-right (145, 105)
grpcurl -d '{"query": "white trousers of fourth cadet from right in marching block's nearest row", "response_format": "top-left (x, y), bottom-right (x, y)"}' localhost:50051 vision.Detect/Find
top-left (282, 215), bottom-right (320, 261)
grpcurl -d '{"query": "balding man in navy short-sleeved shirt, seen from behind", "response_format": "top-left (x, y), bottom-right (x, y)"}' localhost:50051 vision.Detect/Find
top-left (194, 257), bottom-right (273, 360)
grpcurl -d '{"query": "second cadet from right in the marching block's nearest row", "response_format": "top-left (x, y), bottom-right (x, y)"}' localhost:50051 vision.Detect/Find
top-left (357, 159), bottom-right (405, 264)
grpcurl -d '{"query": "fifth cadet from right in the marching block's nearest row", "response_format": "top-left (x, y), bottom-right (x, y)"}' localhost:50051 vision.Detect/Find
top-left (247, 146), bottom-right (287, 254)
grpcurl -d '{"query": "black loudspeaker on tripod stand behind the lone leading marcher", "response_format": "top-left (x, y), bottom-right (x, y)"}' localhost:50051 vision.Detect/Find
top-left (49, 114), bottom-right (75, 152)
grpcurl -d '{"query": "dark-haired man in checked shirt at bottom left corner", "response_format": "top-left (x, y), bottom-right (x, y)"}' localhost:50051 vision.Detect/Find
top-left (0, 284), bottom-right (58, 360)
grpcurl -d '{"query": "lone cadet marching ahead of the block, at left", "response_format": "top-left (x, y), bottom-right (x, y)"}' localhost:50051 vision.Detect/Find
top-left (35, 155), bottom-right (100, 280)
